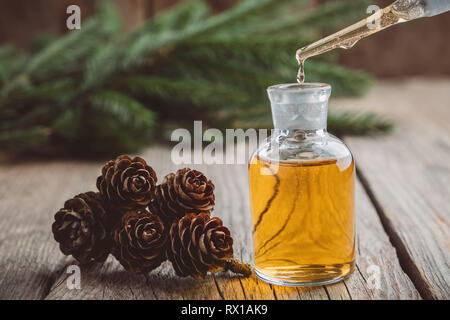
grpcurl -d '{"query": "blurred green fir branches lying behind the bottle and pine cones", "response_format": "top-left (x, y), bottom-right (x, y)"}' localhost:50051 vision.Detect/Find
top-left (0, 0), bottom-right (391, 156)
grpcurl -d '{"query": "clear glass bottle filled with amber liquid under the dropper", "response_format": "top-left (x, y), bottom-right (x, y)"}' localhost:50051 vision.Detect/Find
top-left (249, 83), bottom-right (355, 286)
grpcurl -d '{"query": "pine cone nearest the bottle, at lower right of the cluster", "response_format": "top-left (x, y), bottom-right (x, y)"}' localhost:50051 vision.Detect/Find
top-left (167, 213), bottom-right (233, 279)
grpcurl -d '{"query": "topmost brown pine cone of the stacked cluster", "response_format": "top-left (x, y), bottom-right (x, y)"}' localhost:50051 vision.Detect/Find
top-left (97, 155), bottom-right (157, 210)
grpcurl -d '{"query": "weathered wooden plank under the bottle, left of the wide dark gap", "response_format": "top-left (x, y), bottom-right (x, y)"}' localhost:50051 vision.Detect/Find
top-left (211, 166), bottom-right (420, 299)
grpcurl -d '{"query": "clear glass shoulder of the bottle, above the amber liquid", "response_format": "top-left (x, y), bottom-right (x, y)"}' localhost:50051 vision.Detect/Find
top-left (251, 133), bottom-right (353, 168)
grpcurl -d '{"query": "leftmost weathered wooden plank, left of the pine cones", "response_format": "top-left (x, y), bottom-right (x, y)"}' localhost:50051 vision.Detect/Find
top-left (0, 161), bottom-right (102, 299)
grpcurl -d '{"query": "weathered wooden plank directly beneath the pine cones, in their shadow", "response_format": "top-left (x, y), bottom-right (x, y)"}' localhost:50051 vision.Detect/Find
top-left (47, 147), bottom-right (222, 299)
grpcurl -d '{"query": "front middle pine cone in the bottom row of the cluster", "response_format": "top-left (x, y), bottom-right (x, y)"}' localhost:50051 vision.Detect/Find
top-left (111, 209), bottom-right (168, 272)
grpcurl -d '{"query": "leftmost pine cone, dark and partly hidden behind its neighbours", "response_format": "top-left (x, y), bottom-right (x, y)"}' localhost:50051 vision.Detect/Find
top-left (52, 192), bottom-right (110, 263)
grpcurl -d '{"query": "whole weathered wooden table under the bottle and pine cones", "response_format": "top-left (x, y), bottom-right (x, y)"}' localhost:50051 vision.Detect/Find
top-left (0, 79), bottom-right (450, 299)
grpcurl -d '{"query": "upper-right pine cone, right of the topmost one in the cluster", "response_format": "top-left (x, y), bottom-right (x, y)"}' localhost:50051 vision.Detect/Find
top-left (149, 168), bottom-right (215, 225)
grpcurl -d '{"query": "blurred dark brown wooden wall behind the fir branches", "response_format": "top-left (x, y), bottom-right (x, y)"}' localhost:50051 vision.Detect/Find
top-left (0, 0), bottom-right (450, 77)
